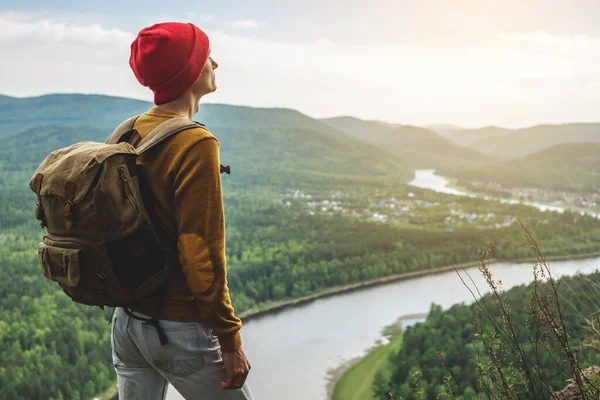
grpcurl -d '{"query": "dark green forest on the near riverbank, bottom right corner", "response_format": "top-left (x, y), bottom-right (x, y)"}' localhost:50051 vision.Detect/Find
top-left (373, 262), bottom-right (600, 400)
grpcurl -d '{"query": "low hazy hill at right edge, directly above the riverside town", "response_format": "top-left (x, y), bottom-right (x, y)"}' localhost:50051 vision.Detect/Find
top-left (453, 143), bottom-right (600, 192)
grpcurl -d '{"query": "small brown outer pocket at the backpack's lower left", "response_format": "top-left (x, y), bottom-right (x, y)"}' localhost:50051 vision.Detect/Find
top-left (38, 242), bottom-right (81, 287)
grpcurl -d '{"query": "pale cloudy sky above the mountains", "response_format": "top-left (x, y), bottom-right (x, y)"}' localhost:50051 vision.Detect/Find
top-left (0, 0), bottom-right (600, 128)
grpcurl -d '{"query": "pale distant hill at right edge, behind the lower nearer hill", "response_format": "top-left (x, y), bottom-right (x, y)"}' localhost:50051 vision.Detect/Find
top-left (460, 123), bottom-right (600, 158)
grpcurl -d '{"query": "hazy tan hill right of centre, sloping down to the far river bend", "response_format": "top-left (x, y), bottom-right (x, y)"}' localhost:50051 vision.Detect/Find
top-left (322, 117), bottom-right (494, 171)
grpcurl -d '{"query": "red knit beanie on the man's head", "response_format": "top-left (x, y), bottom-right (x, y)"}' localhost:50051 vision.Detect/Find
top-left (129, 22), bottom-right (209, 104)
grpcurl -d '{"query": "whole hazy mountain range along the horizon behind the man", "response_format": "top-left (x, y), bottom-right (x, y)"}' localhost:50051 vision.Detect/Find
top-left (0, 94), bottom-right (600, 194)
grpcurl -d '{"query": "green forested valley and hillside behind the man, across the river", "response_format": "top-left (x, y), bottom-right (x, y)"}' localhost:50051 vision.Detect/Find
top-left (0, 96), bottom-right (600, 400)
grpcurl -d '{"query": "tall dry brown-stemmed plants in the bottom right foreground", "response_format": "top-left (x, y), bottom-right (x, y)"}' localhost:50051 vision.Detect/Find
top-left (455, 220), bottom-right (600, 400)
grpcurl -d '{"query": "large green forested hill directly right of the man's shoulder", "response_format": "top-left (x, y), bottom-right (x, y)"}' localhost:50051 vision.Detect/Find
top-left (198, 105), bottom-right (413, 188)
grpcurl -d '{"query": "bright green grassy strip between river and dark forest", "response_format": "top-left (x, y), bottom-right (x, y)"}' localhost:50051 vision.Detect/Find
top-left (333, 327), bottom-right (402, 400)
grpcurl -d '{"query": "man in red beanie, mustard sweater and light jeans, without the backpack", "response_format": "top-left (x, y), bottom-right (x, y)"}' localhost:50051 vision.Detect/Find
top-left (111, 22), bottom-right (252, 400)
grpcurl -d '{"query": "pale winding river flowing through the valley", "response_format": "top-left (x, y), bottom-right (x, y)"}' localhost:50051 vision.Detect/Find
top-left (162, 171), bottom-right (600, 400)
